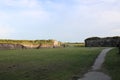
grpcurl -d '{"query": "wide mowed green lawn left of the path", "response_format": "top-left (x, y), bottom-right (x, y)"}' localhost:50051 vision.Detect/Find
top-left (0, 47), bottom-right (103, 80)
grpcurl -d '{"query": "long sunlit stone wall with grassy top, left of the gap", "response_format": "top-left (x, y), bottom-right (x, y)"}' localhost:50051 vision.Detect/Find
top-left (0, 40), bottom-right (61, 49)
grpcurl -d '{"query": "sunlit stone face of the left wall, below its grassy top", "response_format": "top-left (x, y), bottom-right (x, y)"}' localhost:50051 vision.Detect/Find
top-left (0, 40), bottom-right (60, 49)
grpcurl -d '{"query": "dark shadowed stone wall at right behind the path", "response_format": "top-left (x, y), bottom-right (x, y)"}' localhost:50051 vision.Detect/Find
top-left (85, 36), bottom-right (120, 47)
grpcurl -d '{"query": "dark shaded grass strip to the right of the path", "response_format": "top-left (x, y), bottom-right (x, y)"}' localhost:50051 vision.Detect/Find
top-left (104, 48), bottom-right (120, 80)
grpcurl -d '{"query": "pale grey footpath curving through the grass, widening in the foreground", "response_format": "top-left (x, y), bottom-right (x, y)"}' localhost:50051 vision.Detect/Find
top-left (78, 48), bottom-right (112, 80)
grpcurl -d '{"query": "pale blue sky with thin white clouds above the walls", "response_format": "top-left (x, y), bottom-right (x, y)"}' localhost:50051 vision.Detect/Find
top-left (0, 0), bottom-right (120, 42)
